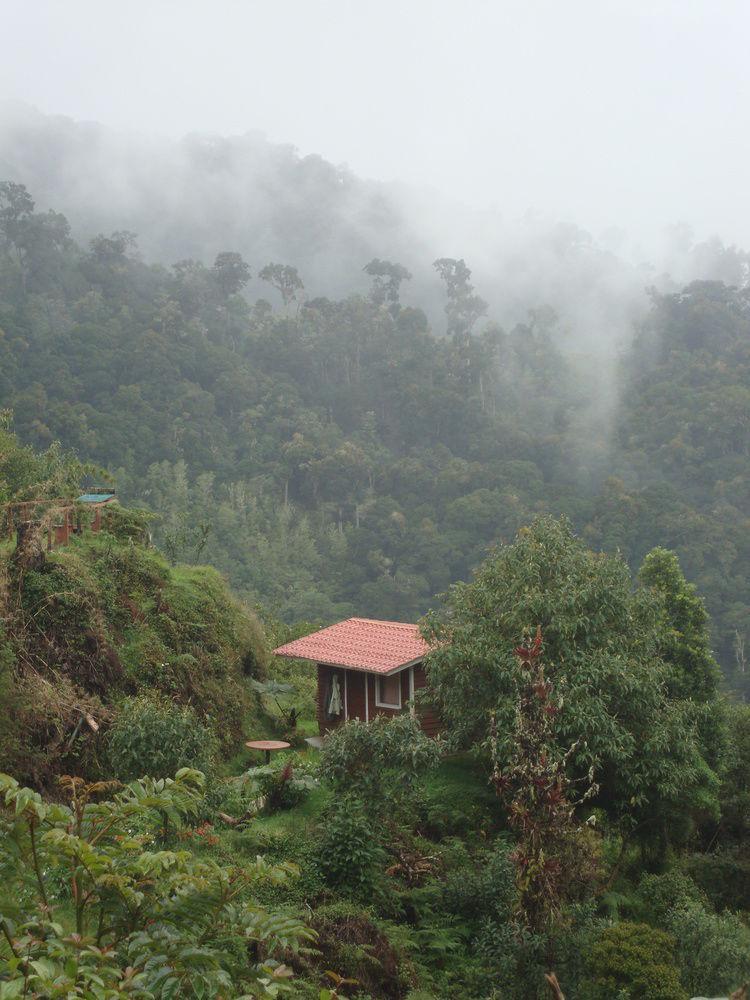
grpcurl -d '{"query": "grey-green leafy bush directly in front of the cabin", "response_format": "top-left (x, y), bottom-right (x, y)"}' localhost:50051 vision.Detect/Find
top-left (320, 715), bottom-right (441, 810)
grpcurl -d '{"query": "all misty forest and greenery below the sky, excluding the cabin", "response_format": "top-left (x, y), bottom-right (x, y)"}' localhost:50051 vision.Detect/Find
top-left (0, 50), bottom-right (750, 1000)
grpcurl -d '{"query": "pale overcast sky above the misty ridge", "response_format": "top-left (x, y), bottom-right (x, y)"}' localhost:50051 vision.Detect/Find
top-left (0, 0), bottom-right (750, 246)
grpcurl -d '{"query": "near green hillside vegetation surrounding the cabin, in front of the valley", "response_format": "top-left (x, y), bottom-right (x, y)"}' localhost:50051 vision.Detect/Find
top-left (5, 430), bottom-right (750, 1000)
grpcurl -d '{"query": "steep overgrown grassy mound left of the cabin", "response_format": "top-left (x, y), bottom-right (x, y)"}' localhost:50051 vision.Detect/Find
top-left (0, 438), bottom-right (266, 787)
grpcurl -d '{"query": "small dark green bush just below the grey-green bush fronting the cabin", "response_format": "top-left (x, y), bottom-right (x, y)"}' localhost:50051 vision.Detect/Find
top-left (319, 795), bottom-right (385, 899)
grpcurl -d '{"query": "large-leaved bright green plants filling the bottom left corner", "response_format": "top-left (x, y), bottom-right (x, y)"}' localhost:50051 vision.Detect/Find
top-left (0, 769), bottom-right (312, 1000)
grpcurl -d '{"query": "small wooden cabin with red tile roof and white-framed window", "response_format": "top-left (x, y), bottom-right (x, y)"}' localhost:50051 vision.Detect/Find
top-left (274, 618), bottom-right (440, 736)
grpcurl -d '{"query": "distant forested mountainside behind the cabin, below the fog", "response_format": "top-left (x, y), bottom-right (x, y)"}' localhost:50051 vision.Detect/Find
top-left (0, 176), bottom-right (750, 691)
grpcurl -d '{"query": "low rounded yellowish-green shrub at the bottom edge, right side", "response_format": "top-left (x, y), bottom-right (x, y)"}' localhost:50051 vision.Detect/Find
top-left (581, 921), bottom-right (687, 1000)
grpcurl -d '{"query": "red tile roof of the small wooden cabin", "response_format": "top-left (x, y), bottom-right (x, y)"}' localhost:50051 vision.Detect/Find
top-left (274, 618), bottom-right (428, 674)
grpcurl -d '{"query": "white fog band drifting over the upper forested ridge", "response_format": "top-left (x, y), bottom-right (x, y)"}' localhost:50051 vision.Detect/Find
top-left (0, 102), bottom-right (748, 353)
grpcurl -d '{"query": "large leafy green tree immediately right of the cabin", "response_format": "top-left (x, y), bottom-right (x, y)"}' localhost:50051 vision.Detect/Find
top-left (425, 517), bottom-right (718, 825)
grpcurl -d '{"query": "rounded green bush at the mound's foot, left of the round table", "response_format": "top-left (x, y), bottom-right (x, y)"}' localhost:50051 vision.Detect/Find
top-left (108, 695), bottom-right (216, 781)
